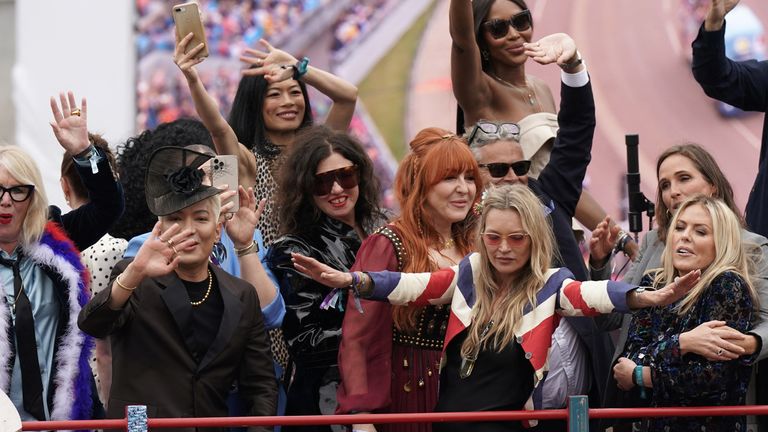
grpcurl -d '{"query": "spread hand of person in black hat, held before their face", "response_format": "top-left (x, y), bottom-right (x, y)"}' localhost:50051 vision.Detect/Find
top-left (131, 222), bottom-right (197, 277)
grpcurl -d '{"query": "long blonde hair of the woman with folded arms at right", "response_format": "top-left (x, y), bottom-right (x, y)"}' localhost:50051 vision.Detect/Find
top-left (653, 195), bottom-right (757, 315)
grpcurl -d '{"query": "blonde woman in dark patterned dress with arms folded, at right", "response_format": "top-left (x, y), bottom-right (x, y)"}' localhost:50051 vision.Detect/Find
top-left (614, 195), bottom-right (757, 432)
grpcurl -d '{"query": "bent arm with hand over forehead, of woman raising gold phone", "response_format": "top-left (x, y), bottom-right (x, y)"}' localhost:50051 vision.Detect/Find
top-left (240, 39), bottom-right (357, 132)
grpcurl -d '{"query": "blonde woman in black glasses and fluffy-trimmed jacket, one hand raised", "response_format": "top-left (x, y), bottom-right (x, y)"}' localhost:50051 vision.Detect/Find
top-left (0, 92), bottom-right (123, 421)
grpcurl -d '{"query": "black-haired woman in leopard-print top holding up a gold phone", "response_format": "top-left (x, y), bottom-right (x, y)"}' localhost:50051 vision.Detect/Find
top-left (173, 33), bottom-right (357, 246)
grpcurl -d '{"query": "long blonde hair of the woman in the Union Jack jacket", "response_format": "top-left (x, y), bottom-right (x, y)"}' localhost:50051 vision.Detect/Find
top-left (461, 184), bottom-right (555, 357)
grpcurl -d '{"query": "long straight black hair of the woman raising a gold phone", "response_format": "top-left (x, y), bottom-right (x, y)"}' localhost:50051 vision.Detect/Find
top-left (229, 71), bottom-right (312, 157)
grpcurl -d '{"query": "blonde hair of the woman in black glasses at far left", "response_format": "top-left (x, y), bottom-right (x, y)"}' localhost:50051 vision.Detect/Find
top-left (0, 146), bottom-right (48, 246)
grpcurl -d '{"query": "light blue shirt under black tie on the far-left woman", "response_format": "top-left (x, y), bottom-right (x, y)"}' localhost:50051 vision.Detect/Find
top-left (0, 250), bottom-right (59, 421)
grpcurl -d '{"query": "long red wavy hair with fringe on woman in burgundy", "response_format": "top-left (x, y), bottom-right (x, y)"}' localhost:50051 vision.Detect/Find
top-left (392, 128), bottom-right (483, 330)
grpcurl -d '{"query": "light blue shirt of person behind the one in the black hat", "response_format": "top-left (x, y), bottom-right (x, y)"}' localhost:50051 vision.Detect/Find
top-left (123, 230), bottom-right (285, 330)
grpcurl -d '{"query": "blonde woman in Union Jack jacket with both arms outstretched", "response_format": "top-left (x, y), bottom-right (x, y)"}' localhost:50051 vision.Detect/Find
top-left (294, 185), bottom-right (698, 432)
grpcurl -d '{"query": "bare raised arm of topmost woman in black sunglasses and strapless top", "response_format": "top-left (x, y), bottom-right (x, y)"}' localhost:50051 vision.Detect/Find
top-left (448, 0), bottom-right (491, 116)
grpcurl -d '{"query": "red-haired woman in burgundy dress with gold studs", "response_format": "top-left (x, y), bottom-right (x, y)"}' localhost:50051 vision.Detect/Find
top-left (337, 128), bottom-right (482, 431)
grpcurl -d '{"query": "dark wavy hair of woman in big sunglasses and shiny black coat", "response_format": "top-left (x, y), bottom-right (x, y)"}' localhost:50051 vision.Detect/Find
top-left (278, 126), bottom-right (383, 234)
